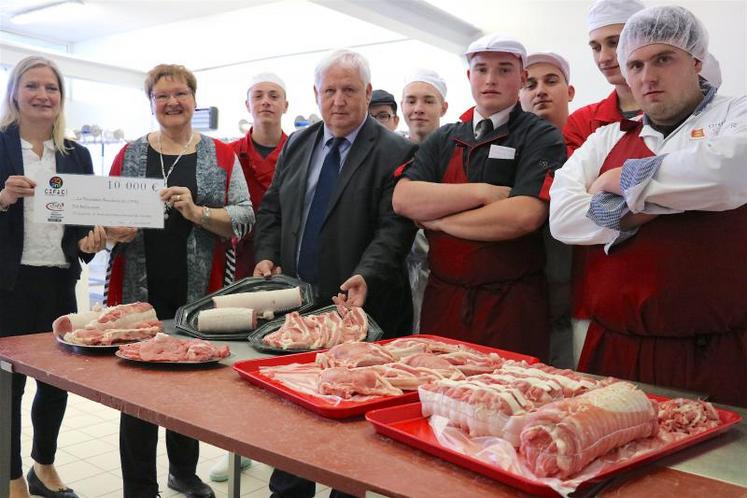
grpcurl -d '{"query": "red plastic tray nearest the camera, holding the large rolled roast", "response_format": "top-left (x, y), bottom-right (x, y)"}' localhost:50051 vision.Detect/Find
top-left (366, 394), bottom-right (742, 497)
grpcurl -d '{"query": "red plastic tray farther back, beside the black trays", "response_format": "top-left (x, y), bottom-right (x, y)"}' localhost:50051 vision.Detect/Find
top-left (233, 334), bottom-right (539, 418)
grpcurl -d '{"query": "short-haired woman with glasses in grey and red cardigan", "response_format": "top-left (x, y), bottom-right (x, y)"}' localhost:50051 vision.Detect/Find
top-left (106, 64), bottom-right (254, 498)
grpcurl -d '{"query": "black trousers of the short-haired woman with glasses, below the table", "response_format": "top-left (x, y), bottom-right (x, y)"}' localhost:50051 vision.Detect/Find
top-left (119, 413), bottom-right (200, 498)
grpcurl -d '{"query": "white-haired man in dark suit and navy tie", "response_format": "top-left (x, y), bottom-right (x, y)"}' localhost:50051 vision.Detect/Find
top-left (254, 50), bottom-right (416, 337)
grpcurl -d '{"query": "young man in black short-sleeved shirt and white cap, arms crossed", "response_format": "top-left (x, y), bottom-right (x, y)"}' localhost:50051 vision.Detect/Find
top-left (393, 35), bottom-right (565, 359)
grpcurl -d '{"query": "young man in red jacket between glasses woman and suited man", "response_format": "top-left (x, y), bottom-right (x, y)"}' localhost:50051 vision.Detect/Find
top-left (231, 73), bottom-right (288, 280)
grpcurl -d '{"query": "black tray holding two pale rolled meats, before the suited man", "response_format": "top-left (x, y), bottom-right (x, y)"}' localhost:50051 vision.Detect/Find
top-left (174, 275), bottom-right (314, 341)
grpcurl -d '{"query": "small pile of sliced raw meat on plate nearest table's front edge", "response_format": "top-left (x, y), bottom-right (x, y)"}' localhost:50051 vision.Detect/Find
top-left (119, 334), bottom-right (231, 362)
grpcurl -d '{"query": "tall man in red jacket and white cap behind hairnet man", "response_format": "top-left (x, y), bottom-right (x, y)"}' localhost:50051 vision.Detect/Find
top-left (563, 0), bottom-right (643, 156)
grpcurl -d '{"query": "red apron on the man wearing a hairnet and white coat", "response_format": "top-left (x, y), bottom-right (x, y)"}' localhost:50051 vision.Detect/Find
top-left (579, 122), bottom-right (747, 406)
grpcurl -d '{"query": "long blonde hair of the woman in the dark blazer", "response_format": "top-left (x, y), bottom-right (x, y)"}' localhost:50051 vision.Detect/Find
top-left (0, 55), bottom-right (67, 154)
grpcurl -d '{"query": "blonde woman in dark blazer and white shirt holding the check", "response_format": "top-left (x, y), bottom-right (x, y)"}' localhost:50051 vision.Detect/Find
top-left (0, 57), bottom-right (106, 498)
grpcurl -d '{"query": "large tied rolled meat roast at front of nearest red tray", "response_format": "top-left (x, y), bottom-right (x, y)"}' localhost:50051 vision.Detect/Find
top-left (519, 382), bottom-right (659, 479)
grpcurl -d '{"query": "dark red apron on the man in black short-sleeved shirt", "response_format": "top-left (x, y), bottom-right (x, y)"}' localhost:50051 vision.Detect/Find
top-left (420, 142), bottom-right (550, 360)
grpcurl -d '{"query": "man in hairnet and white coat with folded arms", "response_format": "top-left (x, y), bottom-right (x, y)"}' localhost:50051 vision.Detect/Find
top-left (550, 7), bottom-right (747, 406)
